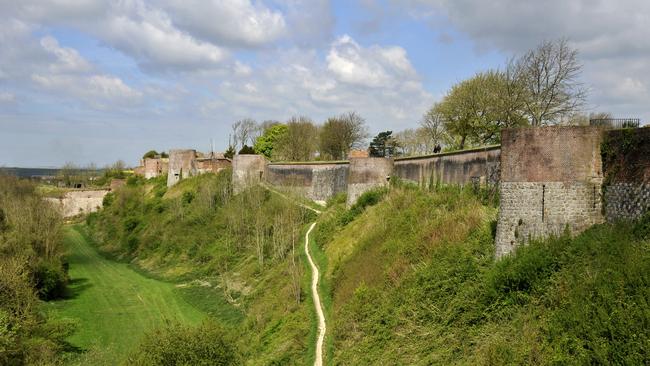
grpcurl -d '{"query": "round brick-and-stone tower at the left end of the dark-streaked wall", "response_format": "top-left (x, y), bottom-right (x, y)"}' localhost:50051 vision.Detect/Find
top-left (347, 158), bottom-right (394, 207)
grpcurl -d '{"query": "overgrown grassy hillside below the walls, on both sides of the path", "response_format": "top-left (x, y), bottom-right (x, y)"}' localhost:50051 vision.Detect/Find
top-left (82, 172), bottom-right (650, 365)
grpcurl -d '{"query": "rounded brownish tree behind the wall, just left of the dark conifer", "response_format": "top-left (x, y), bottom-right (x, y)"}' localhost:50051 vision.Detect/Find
top-left (319, 112), bottom-right (368, 160)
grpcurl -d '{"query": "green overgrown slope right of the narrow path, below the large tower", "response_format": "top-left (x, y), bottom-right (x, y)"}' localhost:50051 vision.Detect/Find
top-left (315, 188), bottom-right (650, 365)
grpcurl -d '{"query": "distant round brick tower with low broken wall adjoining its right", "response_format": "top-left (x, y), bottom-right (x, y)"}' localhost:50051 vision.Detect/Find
top-left (167, 150), bottom-right (231, 187)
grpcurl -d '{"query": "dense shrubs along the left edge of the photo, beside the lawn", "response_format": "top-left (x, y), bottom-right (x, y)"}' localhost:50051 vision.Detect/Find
top-left (0, 175), bottom-right (74, 365)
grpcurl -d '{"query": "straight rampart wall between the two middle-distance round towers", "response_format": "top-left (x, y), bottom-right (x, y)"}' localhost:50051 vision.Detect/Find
top-left (265, 162), bottom-right (349, 202)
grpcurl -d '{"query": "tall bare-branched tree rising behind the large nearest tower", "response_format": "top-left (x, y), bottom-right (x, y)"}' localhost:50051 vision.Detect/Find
top-left (509, 39), bottom-right (587, 126)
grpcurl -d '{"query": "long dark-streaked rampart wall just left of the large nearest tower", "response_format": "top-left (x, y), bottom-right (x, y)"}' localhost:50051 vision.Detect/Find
top-left (393, 146), bottom-right (501, 186)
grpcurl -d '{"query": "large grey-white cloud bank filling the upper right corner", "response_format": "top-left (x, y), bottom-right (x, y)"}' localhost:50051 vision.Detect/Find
top-left (393, 0), bottom-right (650, 121)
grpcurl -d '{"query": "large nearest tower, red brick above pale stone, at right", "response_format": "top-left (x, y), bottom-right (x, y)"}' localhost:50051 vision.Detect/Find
top-left (496, 126), bottom-right (603, 257)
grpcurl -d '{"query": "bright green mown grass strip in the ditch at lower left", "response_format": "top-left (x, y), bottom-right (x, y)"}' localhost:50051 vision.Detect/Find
top-left (46, 227), bottom-right (206, 364)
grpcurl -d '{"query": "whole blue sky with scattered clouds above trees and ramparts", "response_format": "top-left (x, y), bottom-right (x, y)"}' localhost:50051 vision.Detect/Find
top-left (0, 0), bottom-right (650, 167)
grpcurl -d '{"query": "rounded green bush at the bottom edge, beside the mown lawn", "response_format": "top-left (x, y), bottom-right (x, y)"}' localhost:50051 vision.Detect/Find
top-left (129, 322), bottom-right (242, 366)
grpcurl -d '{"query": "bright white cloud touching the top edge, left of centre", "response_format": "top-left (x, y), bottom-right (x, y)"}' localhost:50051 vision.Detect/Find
top-left (164, 0), bottom-right (286, 47)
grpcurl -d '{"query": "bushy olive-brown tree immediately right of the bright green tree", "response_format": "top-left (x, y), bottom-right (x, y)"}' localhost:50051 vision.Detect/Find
top-left (274, 117), bottom-right (318, 161)
